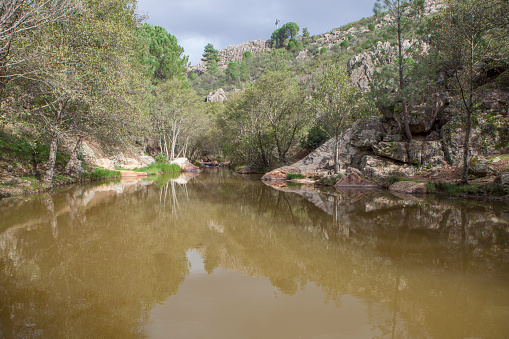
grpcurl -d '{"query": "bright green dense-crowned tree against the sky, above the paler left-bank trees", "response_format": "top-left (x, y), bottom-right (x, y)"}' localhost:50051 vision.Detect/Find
top-left (138, 23), bottom-right (189, 81)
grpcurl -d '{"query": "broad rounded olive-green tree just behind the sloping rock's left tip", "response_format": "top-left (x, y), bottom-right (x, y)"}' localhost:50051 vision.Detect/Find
top-left (221, 71), bottom-right (309, 167)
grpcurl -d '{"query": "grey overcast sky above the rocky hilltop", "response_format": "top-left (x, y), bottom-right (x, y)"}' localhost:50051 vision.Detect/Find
top-left (138, 0), bottom-right (375, 65)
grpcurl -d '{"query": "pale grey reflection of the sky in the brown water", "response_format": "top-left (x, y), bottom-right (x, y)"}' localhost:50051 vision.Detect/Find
top-left (143, 250), bottom-right (380, 338)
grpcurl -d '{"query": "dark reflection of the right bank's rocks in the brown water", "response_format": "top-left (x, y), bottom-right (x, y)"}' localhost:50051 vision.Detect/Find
top-left (265, 182), bottom-right (509, 259)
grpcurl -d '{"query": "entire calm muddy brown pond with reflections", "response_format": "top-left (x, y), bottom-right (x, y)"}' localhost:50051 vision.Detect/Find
top-left (0, 170), bottom-right (509, 338)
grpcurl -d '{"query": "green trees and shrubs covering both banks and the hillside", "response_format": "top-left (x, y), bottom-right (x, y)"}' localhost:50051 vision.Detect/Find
top-left (0, 0), bottom-right (509, 195)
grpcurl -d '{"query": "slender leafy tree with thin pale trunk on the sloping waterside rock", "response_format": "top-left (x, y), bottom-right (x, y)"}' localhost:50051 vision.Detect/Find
top-left (312, 65), bottom-right (370, 173)
